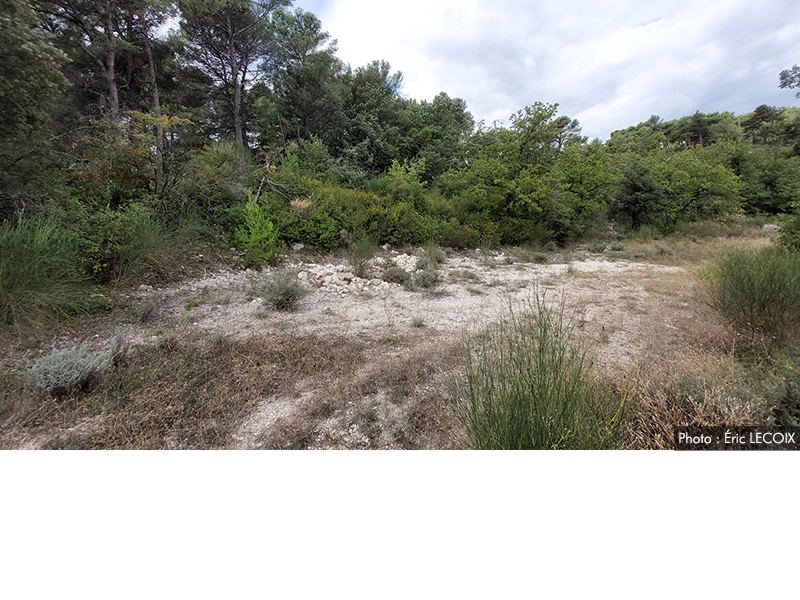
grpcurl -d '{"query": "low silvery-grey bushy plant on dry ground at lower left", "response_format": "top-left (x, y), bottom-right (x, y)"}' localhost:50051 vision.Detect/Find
top-left (30, 342), bottom-right (112, 395)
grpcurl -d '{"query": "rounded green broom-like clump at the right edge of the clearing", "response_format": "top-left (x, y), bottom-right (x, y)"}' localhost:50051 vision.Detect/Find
top-left (710, 247), bottom-right (800, 345)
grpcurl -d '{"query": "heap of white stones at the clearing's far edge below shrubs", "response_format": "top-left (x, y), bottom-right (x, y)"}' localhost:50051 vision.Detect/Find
top-left (297, 254), bottom-right (417, 296)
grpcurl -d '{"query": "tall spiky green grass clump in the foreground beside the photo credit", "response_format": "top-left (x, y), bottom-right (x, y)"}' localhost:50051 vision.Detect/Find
top-left (457, 295), bottom-right (624, 450)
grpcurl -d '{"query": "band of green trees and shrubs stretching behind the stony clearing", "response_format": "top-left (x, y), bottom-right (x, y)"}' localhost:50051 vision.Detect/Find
top-left (0, 0), bottom-right (800, 321)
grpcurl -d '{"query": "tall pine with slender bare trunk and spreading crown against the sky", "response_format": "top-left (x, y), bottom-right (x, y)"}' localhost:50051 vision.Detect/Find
top-left (179, 0), bottom-right (290, 145)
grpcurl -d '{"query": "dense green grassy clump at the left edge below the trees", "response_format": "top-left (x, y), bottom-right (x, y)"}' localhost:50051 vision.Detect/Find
top-left (0, 219), bottom-right (89, 324)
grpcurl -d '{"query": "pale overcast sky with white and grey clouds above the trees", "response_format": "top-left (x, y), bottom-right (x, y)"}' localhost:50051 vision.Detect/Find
top-left (294, 0), bottom-right (800, 140)
